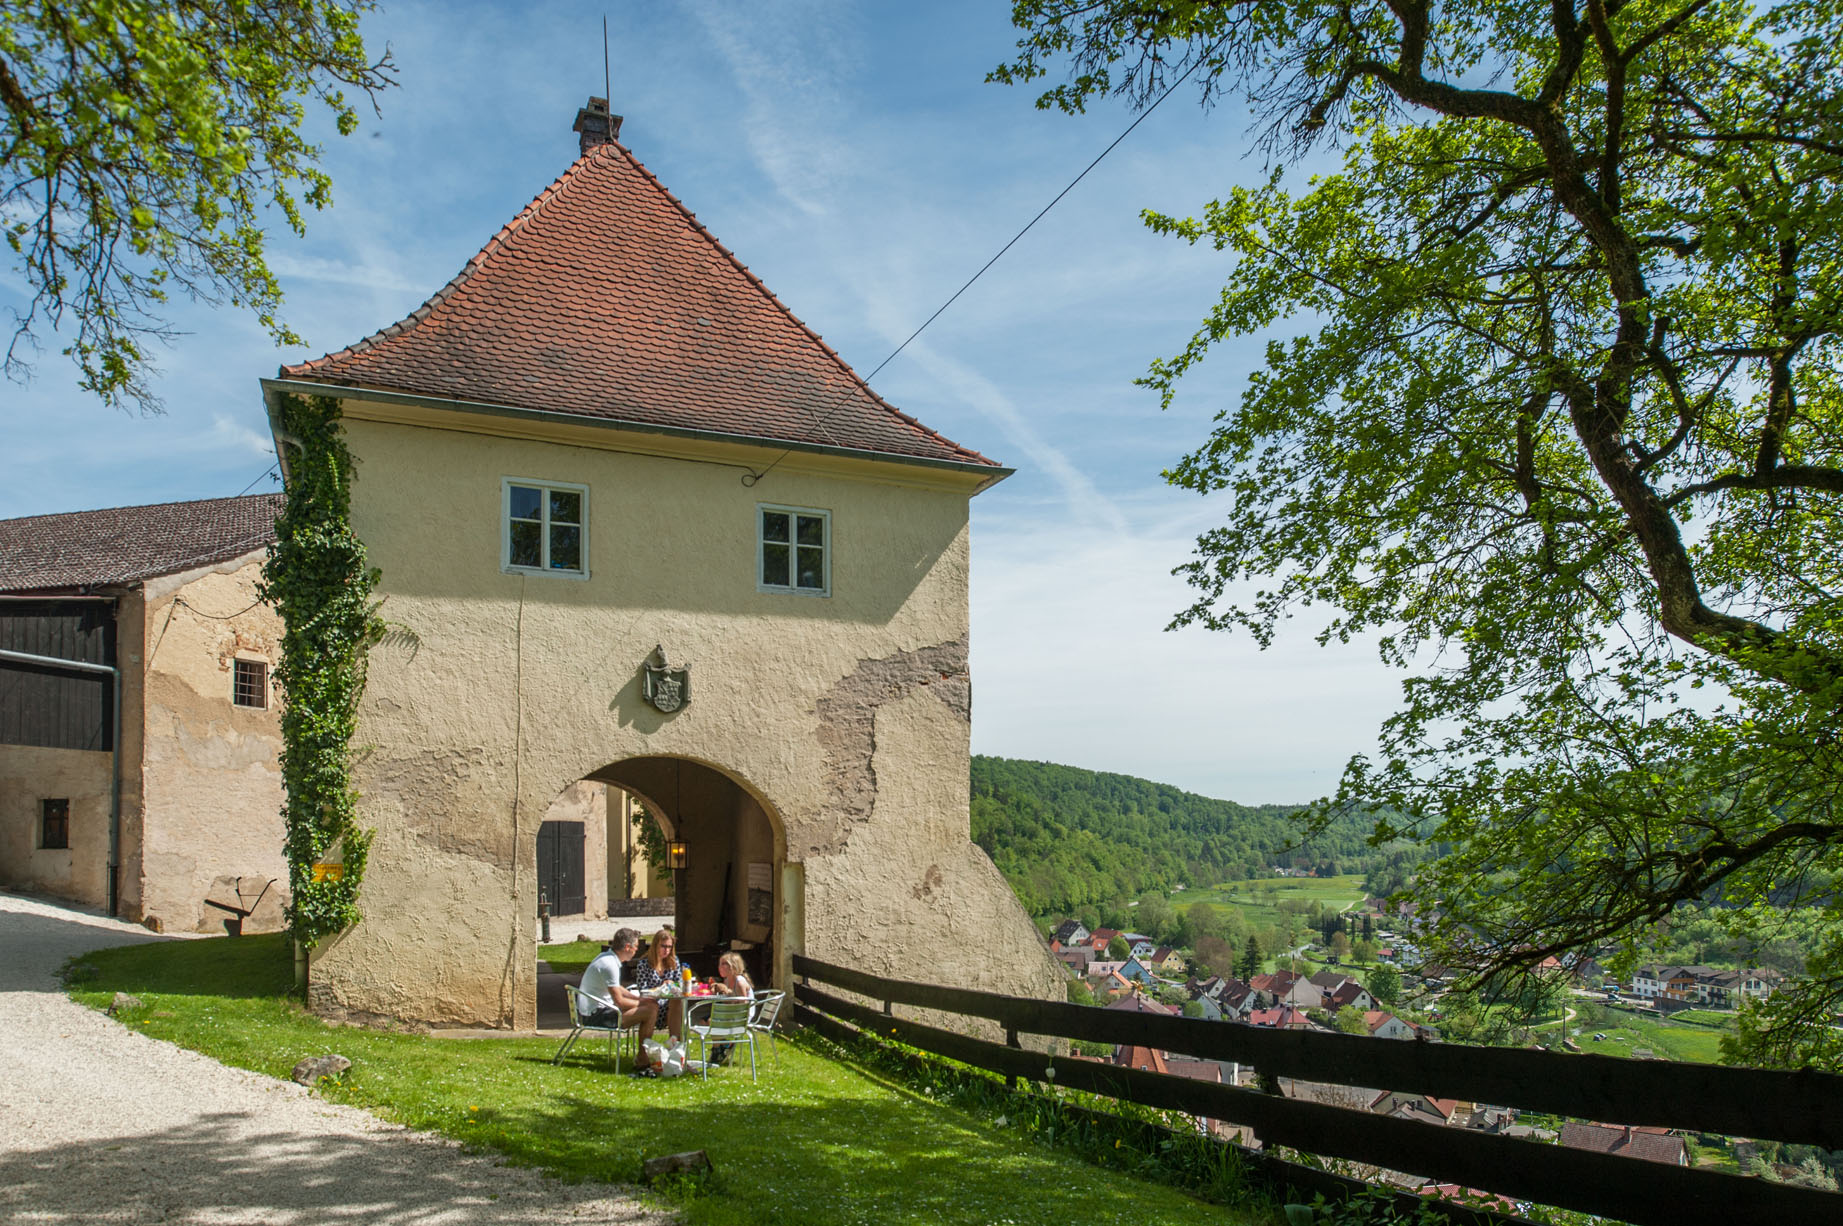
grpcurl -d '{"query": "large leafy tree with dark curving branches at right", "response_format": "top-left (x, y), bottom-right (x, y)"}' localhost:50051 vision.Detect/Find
top-left (993, 0), bottom-right (1843, 1067)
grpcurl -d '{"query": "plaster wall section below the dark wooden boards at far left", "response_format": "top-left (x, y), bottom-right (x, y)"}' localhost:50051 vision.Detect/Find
top-left (0, 745), bottom-right (111, 907)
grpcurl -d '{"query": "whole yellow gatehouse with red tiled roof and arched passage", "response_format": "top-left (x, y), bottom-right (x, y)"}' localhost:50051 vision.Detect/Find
top-left (264, 100), bottom-right (1062, 1029)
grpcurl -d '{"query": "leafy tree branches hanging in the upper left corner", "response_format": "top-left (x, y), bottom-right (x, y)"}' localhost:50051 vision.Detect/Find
top-left (0, 0), bottom-right (391, 409)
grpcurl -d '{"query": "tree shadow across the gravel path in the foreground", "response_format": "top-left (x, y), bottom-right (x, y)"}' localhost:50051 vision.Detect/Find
top-left (0, 1112), bottom-right (652, 1226)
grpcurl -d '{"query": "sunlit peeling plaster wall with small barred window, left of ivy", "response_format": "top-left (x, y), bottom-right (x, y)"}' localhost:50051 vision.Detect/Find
top-left (133, 551), bottom-right (288, 933)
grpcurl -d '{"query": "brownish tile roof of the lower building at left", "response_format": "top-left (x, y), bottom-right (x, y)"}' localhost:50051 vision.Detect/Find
top-left (0, 494), bottom-right (282, 592)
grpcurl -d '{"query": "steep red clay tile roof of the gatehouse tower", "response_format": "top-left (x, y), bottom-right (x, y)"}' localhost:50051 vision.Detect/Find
top-left (282, 144), bottom-right (995, 466)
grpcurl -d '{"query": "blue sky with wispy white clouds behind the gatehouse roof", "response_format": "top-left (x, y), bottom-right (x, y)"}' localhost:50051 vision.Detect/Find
top-left (0, 0), bottom-right (1399, 802)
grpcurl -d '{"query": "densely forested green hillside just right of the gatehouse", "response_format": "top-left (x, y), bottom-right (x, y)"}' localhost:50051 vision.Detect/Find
top-left (973, 756), bottom-right (1379, 914)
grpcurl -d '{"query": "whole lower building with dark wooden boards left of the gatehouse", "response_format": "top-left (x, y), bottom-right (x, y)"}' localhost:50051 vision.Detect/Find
top-left (0, 494), bottom-right (288, 933)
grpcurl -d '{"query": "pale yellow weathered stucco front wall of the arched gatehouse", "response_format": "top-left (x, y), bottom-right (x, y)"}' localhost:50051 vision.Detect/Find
top-left (311, 402), bottom-right (1062, 1029)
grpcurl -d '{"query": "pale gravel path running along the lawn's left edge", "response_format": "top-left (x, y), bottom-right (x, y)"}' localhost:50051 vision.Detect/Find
top-left (0, 892), bottom-right (671, 1226)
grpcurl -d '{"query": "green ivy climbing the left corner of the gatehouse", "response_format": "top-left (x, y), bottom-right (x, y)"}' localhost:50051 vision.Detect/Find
top-left (256, 396), bottom-right (383, 948)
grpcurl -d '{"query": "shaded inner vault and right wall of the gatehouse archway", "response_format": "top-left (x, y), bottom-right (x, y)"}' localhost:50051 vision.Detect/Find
top-left (584, 756), bottom-right (800, 986)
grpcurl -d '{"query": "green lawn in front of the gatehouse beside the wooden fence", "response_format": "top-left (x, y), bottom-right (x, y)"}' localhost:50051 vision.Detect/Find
top-left (72, 937), bottom-right (1275, 1226)
